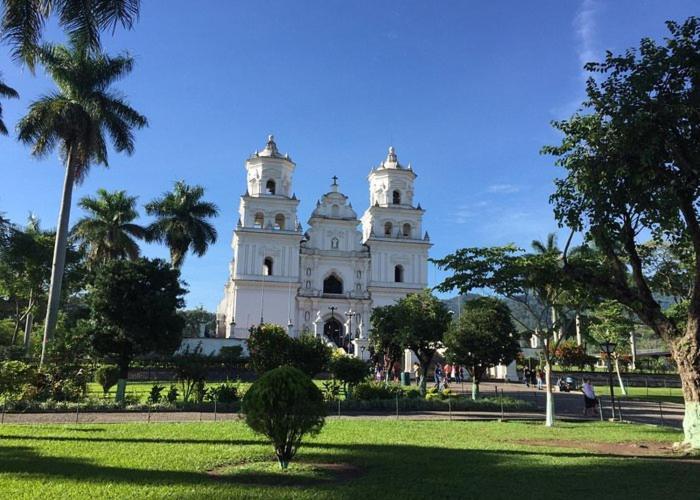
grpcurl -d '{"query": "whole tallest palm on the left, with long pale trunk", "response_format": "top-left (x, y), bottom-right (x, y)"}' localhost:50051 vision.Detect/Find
top-left (17, 45), bottom-right (147, 366)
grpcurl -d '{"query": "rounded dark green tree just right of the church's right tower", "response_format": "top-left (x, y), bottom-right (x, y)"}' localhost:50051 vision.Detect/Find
top-left (444, 297), bottom-right (520, 399)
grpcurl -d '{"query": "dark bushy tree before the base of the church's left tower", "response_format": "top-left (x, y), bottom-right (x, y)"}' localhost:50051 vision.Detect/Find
top-left (248, 323), bottom-right (291, 375)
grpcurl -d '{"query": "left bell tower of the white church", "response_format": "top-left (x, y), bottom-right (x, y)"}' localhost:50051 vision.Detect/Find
top-left (218, 135), bottom-right (302, 338)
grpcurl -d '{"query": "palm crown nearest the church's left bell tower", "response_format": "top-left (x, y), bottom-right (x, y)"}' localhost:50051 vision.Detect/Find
top-left (146, 181), bottom-right (219, 269)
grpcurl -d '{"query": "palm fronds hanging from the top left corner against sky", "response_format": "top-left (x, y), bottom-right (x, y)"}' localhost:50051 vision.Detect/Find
top-left (0, 0), bottom-right (141, 70)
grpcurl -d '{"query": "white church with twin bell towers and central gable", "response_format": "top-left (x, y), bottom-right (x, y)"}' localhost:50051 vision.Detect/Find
top-left (217, 136), bottom-right (431, 358)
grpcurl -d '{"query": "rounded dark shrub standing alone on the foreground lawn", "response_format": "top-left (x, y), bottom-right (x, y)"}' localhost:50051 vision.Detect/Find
top-left (243, 366), bottom-right (326, 469)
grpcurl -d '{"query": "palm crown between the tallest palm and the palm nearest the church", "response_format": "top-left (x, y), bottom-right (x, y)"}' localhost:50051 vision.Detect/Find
top-left (73, 189), bottom-right (146, 262)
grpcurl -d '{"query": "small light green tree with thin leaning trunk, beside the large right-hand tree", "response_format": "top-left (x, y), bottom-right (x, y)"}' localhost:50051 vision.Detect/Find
top-left (590, 300), bottom-right (635, 395)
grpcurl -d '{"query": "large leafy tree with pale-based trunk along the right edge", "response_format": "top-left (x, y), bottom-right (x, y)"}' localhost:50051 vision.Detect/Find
top-left (544, 17), bottom-right (700, 448)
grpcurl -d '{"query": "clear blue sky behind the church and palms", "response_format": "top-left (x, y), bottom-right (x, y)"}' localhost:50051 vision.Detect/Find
top-left (0, 0), bottom-right (697, 310)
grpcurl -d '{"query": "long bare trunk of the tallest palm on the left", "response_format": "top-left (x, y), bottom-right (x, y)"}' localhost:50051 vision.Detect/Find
top-left (39, 154), bottom-right (75, 370)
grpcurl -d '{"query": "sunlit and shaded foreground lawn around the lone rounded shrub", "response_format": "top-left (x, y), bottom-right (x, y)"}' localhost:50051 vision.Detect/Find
top-left (0, 420), bottom-right (700, 500)
